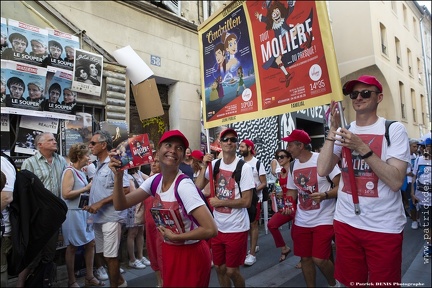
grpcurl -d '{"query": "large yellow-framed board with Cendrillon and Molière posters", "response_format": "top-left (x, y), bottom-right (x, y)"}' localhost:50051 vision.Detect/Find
top-left (198, 1), bottom-right (342, 128)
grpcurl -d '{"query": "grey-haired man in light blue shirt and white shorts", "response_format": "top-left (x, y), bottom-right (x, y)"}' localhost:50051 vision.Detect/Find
top-left (83, 130), bottom-right (129, 287)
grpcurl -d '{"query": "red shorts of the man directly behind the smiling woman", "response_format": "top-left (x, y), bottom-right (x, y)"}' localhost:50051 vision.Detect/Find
top-left (212, 231), bottom-right (249, 268)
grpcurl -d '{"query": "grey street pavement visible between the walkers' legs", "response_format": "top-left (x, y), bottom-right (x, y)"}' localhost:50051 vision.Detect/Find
top-left (10, 219), bottom-right (431, 287)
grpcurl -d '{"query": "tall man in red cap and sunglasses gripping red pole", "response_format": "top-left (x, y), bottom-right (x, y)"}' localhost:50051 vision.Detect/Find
top-left (318, 75), bottom-right (410, 286)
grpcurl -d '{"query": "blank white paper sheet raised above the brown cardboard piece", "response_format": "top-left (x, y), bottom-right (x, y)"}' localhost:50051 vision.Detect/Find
top-left (112, 45), bottom-right (154, 85)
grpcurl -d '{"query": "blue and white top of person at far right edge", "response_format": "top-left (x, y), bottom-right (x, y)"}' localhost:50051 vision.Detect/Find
top-left (413, 156), bottom-right (432, 206)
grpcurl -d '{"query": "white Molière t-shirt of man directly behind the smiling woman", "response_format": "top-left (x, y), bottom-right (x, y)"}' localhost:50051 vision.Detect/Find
top-left (205, 158), bottom-right (255, 233)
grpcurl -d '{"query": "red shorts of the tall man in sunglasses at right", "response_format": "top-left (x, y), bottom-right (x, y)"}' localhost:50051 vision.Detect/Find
top-left (334, 220), bottom-right (403, 287)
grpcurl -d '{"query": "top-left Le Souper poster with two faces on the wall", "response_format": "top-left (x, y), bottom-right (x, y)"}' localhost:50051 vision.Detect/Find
top-left (1, 19), bottom-right (48, 66)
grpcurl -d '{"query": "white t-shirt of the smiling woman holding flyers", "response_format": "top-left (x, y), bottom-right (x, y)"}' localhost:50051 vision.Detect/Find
top-left (140, 171), bottom-right (205, 244)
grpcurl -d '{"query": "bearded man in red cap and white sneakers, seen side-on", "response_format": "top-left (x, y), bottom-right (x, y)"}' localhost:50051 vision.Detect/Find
top-left (239, 139), bottom-right (267, 266)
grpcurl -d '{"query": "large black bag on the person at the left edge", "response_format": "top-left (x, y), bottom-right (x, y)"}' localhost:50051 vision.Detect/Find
top-left (1, 152), bottom-right (68, 276)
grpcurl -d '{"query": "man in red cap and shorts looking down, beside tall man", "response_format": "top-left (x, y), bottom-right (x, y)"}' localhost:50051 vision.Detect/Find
top-left (282, 129), bottom-right (340, 287)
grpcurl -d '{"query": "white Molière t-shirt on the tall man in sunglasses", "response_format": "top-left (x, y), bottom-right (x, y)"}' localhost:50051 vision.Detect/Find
top-left (333, 117), bottom-right (410, 233)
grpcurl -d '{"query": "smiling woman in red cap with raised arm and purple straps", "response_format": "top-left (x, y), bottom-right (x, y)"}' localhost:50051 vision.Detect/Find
top-left (109, 130), bottom-right (217, 287)
